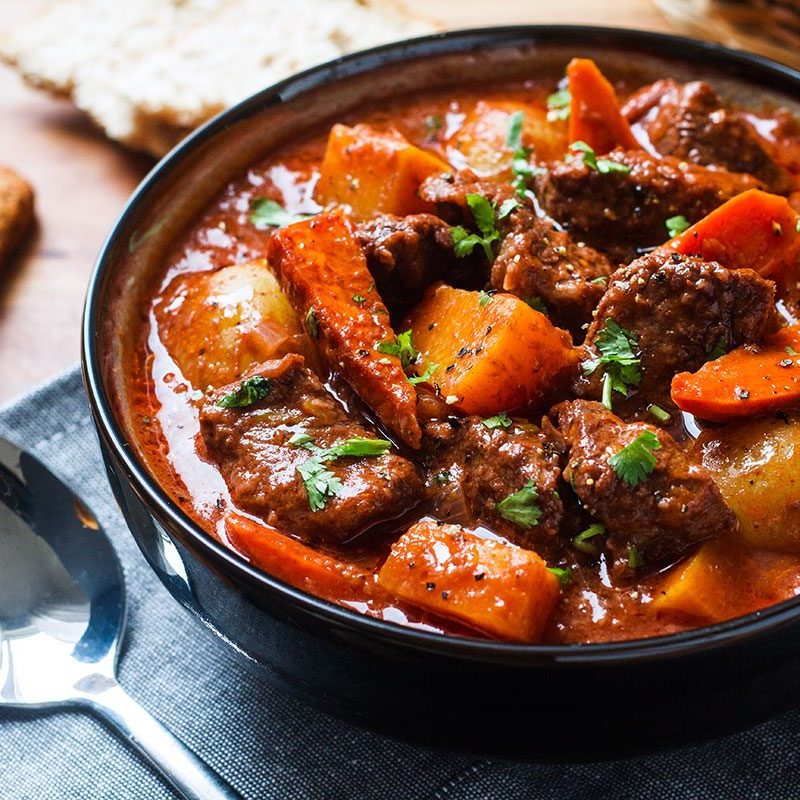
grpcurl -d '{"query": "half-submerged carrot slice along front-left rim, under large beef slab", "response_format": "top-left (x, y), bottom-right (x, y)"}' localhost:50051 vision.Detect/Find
top-left (225, 513), bottom-right (375, 600)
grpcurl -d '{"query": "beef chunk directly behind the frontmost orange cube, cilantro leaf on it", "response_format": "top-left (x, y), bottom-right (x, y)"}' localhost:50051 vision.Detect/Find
top-left (423, 417), bottom-right (564, 557)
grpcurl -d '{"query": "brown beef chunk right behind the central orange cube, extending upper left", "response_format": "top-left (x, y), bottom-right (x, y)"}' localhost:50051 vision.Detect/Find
top-left (421, 172), bottom-right (612, 339)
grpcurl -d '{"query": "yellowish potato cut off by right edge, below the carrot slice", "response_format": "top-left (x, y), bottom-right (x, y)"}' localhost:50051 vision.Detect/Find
top-left (698, 412), bottom-right (800, 554)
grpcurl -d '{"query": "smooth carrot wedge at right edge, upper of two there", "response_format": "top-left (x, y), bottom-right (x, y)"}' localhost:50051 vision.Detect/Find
top-left (658, 189), bottom-right (800, 286)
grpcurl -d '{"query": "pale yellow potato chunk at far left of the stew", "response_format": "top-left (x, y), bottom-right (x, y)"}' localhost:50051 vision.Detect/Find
top-left (155, 259), bottom-right (318, 390)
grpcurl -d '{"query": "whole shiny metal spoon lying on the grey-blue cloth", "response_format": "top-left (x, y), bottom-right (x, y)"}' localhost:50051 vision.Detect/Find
top-left (0, 439), bottom-right (240, 800)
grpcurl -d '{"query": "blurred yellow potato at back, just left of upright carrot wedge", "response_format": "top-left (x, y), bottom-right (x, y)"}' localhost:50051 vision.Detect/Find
top-left (445, 100), bottom-right (568, 180)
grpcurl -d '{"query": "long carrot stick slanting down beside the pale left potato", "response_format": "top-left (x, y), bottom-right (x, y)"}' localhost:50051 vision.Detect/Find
top-left (269, 213), bottom-right (422, 447)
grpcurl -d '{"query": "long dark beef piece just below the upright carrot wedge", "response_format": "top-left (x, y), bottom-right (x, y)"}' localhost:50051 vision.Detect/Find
top-left (536, 149), bottom-right (762, 253)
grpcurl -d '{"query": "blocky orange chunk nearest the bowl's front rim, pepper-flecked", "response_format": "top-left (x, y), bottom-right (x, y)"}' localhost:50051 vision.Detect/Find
top-left (378, 520), bottom-right (560, 642)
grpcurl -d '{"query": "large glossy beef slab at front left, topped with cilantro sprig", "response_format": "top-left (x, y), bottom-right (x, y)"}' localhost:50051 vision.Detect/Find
top-left (200, 354), bottom-right (422, 541)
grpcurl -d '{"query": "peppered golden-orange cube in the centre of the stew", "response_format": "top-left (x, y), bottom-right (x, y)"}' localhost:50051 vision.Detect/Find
top-left (403, 284), bottom-right (578, 416)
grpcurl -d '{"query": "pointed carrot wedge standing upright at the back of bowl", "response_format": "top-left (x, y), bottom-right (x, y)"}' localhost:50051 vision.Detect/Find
top-left (567, 58), bottom-right (641, 155)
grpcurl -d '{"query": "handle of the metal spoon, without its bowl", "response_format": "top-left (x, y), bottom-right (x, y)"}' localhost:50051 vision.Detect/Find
top-left (79, 675), bottom-right (242, 800)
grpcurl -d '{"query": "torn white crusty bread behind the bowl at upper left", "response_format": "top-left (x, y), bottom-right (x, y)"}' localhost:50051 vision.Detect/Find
top-left (0, 0), bottom-right (435, 155)
